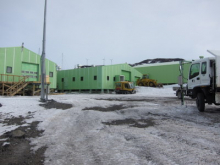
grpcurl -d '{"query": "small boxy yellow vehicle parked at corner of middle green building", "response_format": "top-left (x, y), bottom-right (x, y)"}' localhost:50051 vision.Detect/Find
top-left (115, 81), bottom-right (136, 94)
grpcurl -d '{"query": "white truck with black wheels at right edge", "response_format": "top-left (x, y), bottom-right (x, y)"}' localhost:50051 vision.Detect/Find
top-left (174, 50), bottom-right (220, 112)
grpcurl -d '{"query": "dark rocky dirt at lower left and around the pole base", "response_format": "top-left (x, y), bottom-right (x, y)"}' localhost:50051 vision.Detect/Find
top-left (0, 100), bottom-right (72, 165)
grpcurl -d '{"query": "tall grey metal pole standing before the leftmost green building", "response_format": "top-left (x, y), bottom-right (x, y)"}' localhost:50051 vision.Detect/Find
top-left (40, 0), bottom-right (47, 102)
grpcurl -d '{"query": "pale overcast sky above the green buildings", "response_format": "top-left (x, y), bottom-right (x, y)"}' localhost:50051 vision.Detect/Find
top-left (0, 0), bottom-right (220, 69)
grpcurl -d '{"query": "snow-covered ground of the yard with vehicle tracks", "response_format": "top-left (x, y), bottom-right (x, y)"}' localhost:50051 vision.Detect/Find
top-left (0, 86), bottom-right (220, 165)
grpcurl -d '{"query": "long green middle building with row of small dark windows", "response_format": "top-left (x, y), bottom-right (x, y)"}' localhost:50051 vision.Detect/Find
top-left (57, 64), bottom-right (142, 92)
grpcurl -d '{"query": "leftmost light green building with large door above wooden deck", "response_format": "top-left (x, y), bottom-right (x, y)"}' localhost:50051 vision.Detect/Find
top-left (0, 47), bottom-right (57, 95)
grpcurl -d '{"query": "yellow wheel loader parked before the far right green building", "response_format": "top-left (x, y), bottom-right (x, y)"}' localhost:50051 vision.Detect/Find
top-left (136, 74), bottom-right (163, 87)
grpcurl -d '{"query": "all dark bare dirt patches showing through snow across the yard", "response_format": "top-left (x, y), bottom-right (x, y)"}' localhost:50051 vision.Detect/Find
top-left (0, 97), bottom-right (220, 165)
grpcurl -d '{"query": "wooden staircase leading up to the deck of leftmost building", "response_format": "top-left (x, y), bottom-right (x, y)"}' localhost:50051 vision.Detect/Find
top-left (5, 77), bottom-right (29, 96)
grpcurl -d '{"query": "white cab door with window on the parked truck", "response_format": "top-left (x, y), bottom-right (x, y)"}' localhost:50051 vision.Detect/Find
top-left (188, 63), bottom-right (201, 89)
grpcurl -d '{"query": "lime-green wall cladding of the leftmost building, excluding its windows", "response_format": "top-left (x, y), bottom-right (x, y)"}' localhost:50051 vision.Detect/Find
top-left (0, 47), bottom-right (57, 88)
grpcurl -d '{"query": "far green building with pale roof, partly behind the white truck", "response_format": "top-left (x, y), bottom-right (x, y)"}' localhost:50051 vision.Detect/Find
top-left (134, 62), bottom-right (190, 84)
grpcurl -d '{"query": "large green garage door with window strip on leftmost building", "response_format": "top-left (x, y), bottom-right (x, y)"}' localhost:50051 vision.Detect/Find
top-left (21, 62), bottom-right (39, 81)
